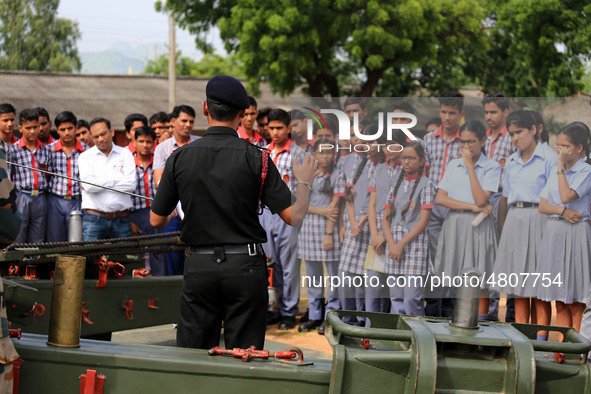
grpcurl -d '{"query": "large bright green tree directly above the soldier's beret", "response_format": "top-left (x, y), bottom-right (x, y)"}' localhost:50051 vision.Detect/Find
top-left (156, 0), bottom-right (484, 97)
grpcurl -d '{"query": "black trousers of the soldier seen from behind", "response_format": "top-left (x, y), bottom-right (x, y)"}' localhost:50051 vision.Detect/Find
top-left (177, 253), bottom-right (269, 349)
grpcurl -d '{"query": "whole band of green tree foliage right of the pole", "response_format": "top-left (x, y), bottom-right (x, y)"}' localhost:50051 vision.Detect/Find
top-left (157, 0), bottom-right (591, 97)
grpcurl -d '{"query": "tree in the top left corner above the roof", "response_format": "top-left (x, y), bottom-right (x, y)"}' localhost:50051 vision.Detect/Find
top-left (0, 0), bottom-right (81, 72)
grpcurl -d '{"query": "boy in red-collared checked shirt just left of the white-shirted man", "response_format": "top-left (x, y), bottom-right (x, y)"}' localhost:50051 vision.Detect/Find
top-left (47, 111), bottom-right (89, 242)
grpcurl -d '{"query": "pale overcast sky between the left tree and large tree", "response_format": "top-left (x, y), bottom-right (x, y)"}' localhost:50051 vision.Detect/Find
top-left (58, 0), bottom-right (222, 59)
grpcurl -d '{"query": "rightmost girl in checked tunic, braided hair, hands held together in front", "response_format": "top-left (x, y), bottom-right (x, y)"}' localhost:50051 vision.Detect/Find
top-left (382, 141), bottom-right (435, 316)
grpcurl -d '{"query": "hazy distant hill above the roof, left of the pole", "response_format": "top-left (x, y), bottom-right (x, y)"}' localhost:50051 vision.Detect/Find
top-left (80, 42), bottom-right (165, 75)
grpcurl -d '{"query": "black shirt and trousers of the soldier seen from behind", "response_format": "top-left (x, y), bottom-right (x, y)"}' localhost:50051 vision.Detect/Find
top-left (152, 127), bottom-right (292, 349)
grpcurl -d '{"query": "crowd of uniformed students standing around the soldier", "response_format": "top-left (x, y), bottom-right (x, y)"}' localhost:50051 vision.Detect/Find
top-left (0, 93), bottom-right (591, 340)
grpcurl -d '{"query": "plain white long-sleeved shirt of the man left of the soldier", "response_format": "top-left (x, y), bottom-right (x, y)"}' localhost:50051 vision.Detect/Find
top-left (78, 144), bottom-right (137, 212)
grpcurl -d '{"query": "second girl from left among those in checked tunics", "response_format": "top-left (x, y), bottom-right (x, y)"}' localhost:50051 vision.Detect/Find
top-left (339, 127), bottom-right (380, 325)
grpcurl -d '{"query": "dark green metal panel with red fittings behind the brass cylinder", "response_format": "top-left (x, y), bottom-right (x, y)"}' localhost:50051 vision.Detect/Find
top-left (4, 276), bottom-right (183, 337)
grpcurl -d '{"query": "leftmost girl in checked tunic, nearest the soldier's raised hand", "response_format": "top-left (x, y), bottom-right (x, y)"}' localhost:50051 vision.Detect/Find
top-left (298, 139), bottom-right (344, 333)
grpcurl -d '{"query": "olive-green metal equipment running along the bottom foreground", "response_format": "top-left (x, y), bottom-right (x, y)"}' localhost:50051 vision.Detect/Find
top-left (8, 311), bottom-right (591, 394)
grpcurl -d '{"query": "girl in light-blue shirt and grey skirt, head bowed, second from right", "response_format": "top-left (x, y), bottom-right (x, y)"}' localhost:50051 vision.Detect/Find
top-left (493, 110), bottom-right (556, 323)
